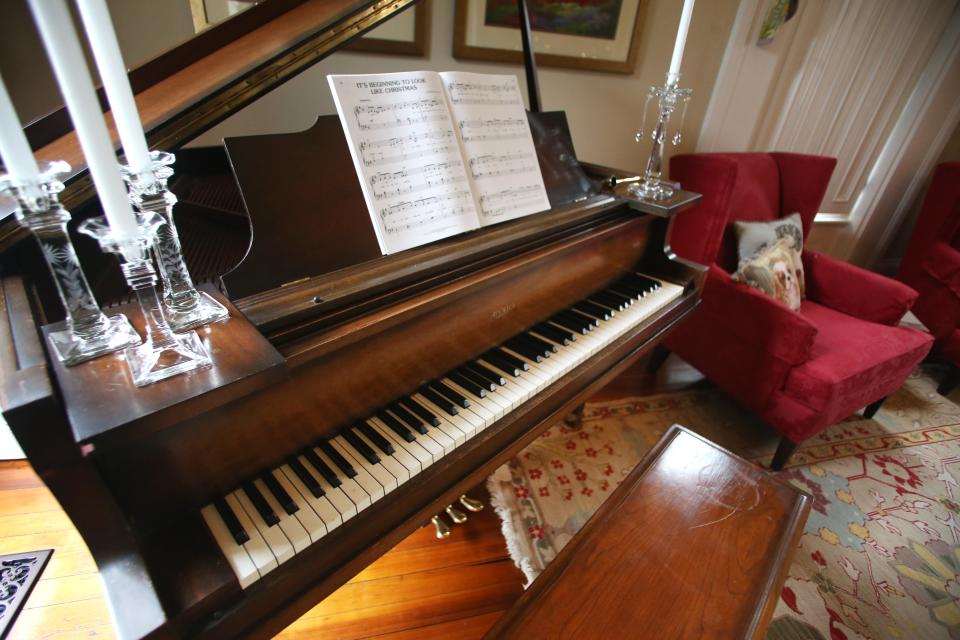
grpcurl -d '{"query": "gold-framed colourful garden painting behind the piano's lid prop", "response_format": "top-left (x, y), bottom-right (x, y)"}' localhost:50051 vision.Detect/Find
top-left (453, 0), bottom-right (649, 73)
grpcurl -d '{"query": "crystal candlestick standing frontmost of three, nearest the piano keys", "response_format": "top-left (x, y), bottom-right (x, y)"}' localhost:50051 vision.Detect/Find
top-left (79, 212), bottom-right (211, 387)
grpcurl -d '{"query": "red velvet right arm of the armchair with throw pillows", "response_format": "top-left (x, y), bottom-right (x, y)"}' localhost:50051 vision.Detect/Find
top-left (803, 250), bottom-right (918, 325)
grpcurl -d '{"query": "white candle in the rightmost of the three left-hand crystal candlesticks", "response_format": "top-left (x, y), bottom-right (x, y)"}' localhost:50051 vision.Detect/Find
top-left (77, 0), bottom-right (151, 173)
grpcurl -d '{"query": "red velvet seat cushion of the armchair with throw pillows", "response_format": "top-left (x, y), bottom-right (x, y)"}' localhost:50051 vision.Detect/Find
top-left (784, 300), bottom-right (933, 424)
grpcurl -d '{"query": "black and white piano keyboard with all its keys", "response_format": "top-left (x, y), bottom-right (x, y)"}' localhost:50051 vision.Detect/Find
top-left (201, 274), bottom-right (683, 588)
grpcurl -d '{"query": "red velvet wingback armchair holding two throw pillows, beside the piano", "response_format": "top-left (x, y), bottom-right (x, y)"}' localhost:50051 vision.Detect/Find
top-left (666, 153), bottom-right (932, 469)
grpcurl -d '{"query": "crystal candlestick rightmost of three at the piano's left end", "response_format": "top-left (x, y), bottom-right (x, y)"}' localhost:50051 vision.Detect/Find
top-left (123, 151), bottom-right (230, 331)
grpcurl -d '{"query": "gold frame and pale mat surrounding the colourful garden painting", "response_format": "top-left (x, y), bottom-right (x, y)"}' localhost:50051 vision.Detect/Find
top-left (453, 0), bottom-right (649, 73)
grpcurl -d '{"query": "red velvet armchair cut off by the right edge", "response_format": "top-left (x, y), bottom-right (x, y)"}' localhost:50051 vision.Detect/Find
top-left (897, 162), bottom-right (960, 393)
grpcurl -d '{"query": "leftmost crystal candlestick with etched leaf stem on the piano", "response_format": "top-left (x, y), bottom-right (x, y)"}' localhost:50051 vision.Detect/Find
top-left (0, 161), bottom-right (140, 366)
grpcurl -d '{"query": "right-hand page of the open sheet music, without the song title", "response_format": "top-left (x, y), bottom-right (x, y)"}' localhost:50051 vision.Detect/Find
top-left (440, 71), bottom-right (550, 226)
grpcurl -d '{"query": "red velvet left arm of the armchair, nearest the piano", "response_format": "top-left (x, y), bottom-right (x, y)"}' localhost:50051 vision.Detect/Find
top-left (703, 265), bottom-right (817, 365)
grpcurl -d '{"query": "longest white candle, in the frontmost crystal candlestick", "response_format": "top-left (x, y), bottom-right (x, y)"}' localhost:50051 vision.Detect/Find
top-left (29, 0), bottom-right (137, 238)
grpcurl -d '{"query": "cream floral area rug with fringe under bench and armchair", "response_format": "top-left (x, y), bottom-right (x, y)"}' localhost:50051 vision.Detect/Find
top-left (488, 373), bottom-right (960, 640)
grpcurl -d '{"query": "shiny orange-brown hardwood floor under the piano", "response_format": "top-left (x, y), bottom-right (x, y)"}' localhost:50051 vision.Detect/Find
top-left (0, 356), bottom-right (703, 640)
